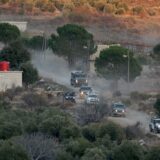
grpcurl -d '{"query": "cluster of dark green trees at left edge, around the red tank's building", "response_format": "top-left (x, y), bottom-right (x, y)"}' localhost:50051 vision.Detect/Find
top-left (0, 23), bottom-right (38, 85)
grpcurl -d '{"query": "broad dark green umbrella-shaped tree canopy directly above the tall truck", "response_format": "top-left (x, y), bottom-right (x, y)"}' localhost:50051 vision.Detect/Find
top-left (49, 24), bottom-right (96, 67)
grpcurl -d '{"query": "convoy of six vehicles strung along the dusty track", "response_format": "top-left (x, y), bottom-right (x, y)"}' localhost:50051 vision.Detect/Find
top-left (68, 71), bottom-right (160, 136)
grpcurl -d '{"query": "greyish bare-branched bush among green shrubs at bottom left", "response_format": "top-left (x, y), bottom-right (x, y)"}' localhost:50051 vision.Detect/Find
top-left (15, 133), bottom-right (57, 160)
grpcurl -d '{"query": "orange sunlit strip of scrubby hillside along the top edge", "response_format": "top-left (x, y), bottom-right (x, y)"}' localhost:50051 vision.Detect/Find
top-left (0, 0), bottom-right (160, 16)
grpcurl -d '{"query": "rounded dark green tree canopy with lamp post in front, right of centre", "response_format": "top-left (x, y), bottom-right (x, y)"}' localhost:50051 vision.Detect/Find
top-left (95, 46), bottom-right (142, 80)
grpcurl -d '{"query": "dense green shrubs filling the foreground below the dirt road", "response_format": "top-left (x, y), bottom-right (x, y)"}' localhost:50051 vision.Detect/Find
top-left (0, 90), bottom-right (159, 160)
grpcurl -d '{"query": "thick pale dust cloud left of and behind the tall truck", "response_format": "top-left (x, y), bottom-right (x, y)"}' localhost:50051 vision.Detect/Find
top-left (32, 50), bottom-right (71, 86)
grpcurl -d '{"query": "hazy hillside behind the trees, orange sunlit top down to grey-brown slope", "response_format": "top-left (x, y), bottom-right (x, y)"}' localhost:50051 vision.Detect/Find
top-left (0, 0), bottom-right (160, 51)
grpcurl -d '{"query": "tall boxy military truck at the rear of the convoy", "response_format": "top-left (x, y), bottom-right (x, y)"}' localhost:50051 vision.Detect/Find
top-left (70, 71), bottom-right (88, 87)
